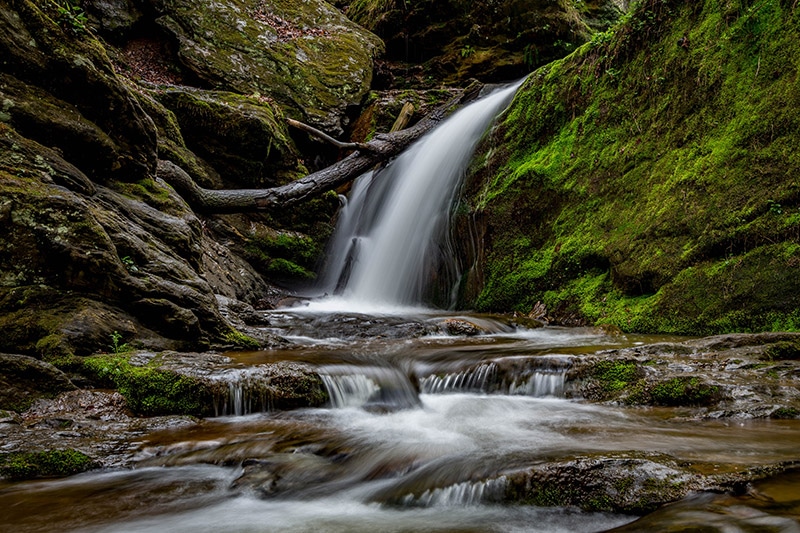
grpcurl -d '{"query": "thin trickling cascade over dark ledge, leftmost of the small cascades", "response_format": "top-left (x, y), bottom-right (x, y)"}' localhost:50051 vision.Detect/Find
top-left (214, 369), bottom-right (272, 416)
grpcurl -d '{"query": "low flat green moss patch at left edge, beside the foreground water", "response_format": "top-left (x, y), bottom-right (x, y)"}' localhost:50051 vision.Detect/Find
top-left (0, 448), bottom-right (93, 481)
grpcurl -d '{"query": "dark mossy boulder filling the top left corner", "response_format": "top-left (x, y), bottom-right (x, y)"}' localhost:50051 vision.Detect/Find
top-left (0, 0), bottom-right (156, 180)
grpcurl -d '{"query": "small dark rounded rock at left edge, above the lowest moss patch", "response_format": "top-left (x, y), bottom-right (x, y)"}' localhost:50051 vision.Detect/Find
top-left (0, 353), bottom-right (76, 412)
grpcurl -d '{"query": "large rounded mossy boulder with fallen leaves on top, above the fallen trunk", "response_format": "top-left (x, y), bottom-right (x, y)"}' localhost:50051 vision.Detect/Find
top-left (155, 0), bottom-right (383, 135)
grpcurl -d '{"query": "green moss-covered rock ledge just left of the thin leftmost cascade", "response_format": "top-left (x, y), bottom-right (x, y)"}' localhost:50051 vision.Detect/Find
top-left (82, 355), bottom-right (213, 416)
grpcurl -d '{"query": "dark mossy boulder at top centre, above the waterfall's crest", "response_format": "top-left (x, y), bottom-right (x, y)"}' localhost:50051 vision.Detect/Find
top-left (347, 0), bottom-right (623, 86)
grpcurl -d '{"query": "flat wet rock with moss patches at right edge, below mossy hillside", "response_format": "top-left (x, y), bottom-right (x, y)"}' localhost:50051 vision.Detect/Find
top-left (568, 333), bottom-right (800, 418)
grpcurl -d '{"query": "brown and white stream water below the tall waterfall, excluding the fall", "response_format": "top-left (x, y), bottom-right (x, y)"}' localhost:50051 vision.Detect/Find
top-left (0, 313), bottom-right (800, 532)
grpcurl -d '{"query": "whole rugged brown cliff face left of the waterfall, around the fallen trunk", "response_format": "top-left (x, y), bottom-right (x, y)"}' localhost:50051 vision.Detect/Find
top-left (0, 0), bottom-right (382, 357)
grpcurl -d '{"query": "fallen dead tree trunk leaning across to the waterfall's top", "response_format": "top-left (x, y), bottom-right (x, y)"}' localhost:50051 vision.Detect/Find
top-left (157, 87), bottom-right (480, 213)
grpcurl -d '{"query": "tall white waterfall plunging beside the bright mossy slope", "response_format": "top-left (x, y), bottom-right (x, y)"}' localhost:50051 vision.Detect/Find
top-left (320, 82), bottom-right (521, 309)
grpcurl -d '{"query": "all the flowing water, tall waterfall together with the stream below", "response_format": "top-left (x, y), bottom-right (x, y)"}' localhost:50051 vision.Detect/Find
top-left (0, 81), bottom-right (800, 533)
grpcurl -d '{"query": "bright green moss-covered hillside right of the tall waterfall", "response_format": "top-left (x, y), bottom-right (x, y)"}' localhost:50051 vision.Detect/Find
top-left (463, 0), bottom-right (800, 334)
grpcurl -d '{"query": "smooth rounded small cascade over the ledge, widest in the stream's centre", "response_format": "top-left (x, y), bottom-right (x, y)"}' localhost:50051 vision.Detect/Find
top-left (319, 365), bottom-right (420, 410)
